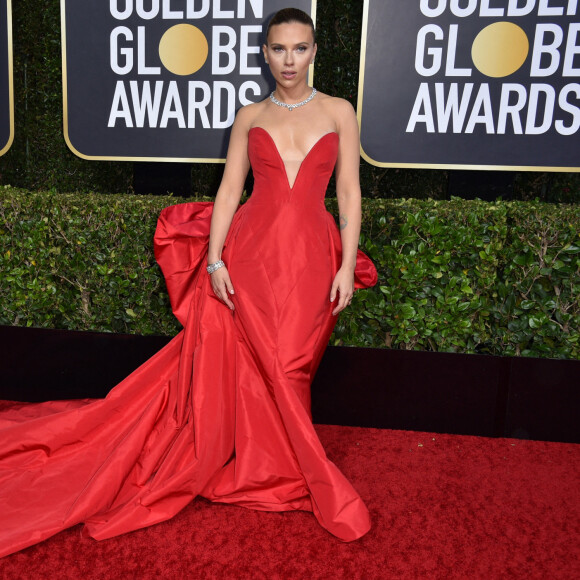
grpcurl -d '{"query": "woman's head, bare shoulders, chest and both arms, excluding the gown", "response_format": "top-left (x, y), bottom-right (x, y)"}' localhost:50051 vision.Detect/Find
top-left (208, 9), bottom-right (361, 315)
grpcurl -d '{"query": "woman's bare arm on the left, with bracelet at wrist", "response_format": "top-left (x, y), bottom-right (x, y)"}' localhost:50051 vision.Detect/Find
top-left (207, 109), bottom-right (250, 310)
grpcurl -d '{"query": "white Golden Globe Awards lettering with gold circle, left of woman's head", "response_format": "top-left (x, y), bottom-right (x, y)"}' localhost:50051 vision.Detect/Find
top-left (108, 0), bottom-right (264, 129)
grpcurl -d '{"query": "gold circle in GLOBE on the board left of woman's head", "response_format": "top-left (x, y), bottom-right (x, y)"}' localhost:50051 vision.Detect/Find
top-left (159, 24), bottom-right (209, 76)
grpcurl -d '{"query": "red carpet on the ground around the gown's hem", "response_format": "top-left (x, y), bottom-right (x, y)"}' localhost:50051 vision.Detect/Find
top-left (0, 425), bottom-right (580, 580)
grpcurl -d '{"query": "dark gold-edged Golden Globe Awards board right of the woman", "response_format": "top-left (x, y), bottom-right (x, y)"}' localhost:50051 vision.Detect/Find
top-left (358, 0), bottom-right (580, 171)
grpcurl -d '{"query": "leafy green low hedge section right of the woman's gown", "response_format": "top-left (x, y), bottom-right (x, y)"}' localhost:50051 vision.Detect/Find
top-left (335, 199), bottom-right (580, 358)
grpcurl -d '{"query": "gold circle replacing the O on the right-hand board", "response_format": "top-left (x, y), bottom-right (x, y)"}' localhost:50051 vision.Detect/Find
top-left (471, 22), bottom-right (530, 78)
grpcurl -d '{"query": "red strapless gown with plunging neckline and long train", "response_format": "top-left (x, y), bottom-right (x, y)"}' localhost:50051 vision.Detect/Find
top-left (0, 128), bottom-right (376, 555)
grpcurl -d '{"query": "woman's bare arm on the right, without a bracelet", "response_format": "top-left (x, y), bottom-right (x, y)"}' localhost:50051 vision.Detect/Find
top-left (330, 99), bottom-right (361, 315)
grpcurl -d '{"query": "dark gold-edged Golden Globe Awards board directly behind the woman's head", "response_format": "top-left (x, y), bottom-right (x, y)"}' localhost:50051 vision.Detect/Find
top-left (61, 0), bottom-right (316, 162)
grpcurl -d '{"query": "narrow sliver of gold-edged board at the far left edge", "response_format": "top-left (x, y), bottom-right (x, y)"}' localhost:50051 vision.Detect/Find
top-left (0, 0), bottom-right (14, 155)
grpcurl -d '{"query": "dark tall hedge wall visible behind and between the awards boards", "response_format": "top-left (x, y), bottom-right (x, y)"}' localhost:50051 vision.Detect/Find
top-left (0, 0), bottom-right (580, 202)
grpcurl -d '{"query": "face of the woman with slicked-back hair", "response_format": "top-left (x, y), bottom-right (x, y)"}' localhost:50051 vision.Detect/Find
top-left (262, 22), bottom-right (316, 88)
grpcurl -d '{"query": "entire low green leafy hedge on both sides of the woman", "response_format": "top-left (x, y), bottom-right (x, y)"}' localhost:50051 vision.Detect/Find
top-left (0, 187), bottom-right (580, 358)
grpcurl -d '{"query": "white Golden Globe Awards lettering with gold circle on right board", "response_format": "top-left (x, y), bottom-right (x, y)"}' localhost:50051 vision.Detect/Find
top-left (406, 0), bottom-right (580, 135)
